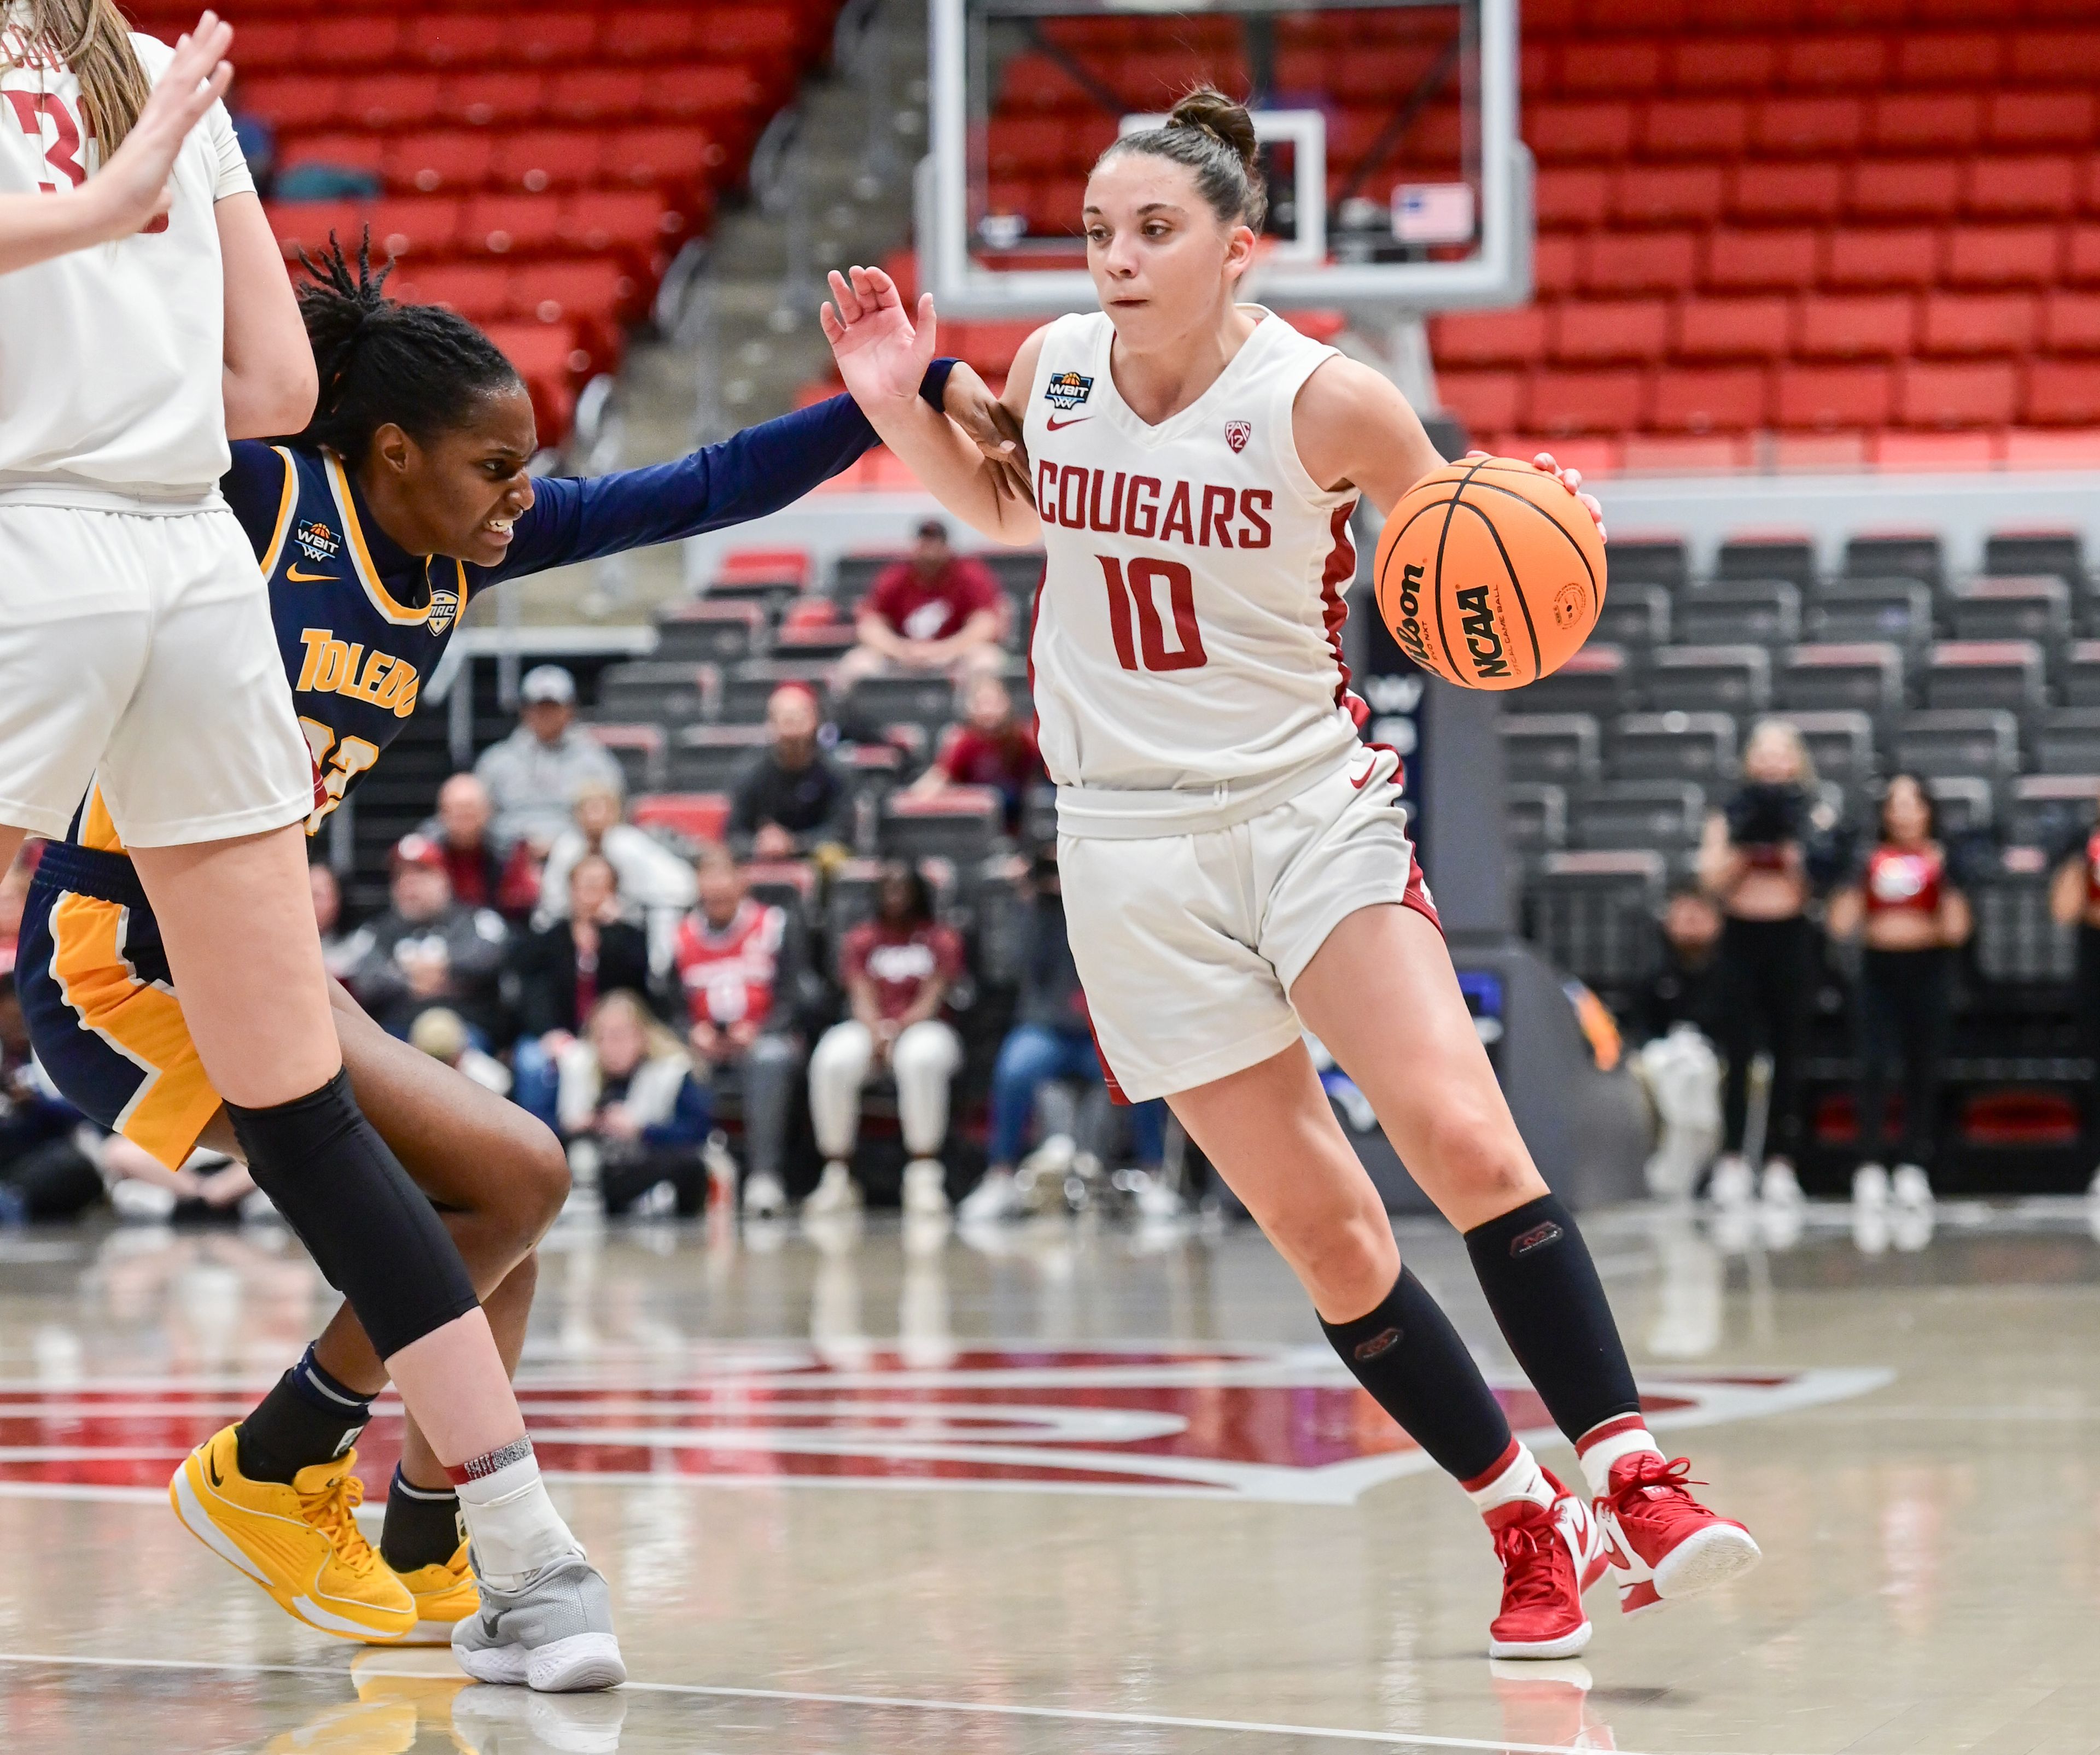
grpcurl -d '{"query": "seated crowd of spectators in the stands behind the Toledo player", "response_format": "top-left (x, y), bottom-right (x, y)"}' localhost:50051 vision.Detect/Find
top-left (0, 629), bottom-right (1172, 1224)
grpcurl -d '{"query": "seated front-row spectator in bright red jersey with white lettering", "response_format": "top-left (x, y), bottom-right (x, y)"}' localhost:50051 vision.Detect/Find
top-left (672, 848), bottom-right (804, 1215)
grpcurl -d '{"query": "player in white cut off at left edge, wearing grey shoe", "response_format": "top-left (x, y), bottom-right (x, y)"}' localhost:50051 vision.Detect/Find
top-left (0, 0), bottom-right (626, 1688)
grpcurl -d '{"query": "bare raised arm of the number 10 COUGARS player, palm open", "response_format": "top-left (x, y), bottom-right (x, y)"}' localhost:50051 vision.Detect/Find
top-left (821, 268), bottom-right (1042, 546)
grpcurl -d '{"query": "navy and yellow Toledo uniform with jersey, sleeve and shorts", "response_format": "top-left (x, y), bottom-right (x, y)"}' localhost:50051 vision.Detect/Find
top-left (15, 379), bottom-right (928, 1167)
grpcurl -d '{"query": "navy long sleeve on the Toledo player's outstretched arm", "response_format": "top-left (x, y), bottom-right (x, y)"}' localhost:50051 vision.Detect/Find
top-left (477, 359), bottom-right (953, 586)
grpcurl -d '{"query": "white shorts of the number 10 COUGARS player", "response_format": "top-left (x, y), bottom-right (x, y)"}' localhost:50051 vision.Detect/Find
top-left (1057, 750), bottom-right (1437, 1102)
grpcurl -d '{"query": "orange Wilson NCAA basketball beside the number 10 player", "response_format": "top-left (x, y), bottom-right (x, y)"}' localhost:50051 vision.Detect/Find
top-left (1378, 458), bottom-right (1605, 688)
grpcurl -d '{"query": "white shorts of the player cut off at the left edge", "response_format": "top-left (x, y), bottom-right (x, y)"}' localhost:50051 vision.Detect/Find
top-left (0, 506), bottom-right (313, 846)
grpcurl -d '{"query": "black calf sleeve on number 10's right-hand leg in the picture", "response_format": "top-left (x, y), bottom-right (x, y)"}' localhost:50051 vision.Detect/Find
top-left (1466, 1195), bottom-right (1640, 1440)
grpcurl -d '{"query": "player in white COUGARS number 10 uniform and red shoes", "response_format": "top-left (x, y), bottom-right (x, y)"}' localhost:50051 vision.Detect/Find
top-left (823, 90), bottom-right (1758, 1658)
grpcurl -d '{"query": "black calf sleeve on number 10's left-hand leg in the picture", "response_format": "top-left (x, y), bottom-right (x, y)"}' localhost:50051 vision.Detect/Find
top-left (1321, 1268), bottom-right (1510, 1480)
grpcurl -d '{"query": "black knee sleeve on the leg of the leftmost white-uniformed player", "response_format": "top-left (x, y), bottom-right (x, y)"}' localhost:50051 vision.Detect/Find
top-left (227, 1073), bottom-right (481, 1358)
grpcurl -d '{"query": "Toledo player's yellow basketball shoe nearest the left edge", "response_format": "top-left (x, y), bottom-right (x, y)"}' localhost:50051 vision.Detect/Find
top-left (168, 1425), bottom-right (416, 1640)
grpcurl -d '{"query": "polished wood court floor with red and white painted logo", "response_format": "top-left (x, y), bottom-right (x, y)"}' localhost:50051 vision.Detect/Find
top-left (0, 1201), bottom-right (2100, 1755)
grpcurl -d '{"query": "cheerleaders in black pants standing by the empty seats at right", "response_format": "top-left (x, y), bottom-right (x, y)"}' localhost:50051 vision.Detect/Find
top-left (1630, 705), bottom-right (2100, 1243)
